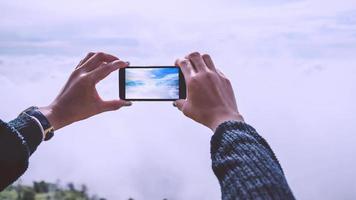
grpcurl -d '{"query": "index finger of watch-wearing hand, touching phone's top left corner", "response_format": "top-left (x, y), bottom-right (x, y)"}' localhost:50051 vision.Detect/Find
top-left (90, 60), bottom-right (128, 83)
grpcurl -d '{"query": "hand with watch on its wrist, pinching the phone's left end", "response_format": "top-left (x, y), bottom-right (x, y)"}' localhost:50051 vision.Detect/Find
top-left (40, 52), bottom-right (131, 130)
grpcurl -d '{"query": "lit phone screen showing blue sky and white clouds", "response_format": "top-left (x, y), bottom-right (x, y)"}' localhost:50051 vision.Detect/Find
top-left (125, 68), bottom-right (179, 99)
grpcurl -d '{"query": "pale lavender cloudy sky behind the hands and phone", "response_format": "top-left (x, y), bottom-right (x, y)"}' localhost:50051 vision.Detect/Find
top-left (0, 0), bottom-right (356, 200)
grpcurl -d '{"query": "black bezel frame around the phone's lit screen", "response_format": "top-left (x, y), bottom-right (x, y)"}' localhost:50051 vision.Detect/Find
top-left (119, 65), bottom-right (186, 101)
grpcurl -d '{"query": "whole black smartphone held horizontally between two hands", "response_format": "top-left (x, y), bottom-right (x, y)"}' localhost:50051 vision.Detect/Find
top-left (119, 66), bottom-right (186, 101)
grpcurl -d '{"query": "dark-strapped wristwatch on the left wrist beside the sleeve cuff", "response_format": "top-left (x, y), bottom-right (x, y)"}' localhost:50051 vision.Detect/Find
top-left (22, 106), bottom-right (54, 141)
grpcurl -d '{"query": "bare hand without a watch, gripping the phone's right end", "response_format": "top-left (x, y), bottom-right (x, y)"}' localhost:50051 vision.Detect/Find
top-left (173, 52), bottom-right (243, 131)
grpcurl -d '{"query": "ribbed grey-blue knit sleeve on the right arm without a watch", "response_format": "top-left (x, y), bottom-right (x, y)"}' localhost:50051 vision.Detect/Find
top-left (211, 121), bottom-right (294, 200)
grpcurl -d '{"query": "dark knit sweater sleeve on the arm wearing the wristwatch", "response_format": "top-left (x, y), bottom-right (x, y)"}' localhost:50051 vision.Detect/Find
top-left (0, 114), bottom-right (43, 191)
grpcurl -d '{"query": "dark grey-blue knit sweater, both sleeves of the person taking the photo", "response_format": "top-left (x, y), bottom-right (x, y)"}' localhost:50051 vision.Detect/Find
top-left (0, 114), bottom-right (294, 200)
